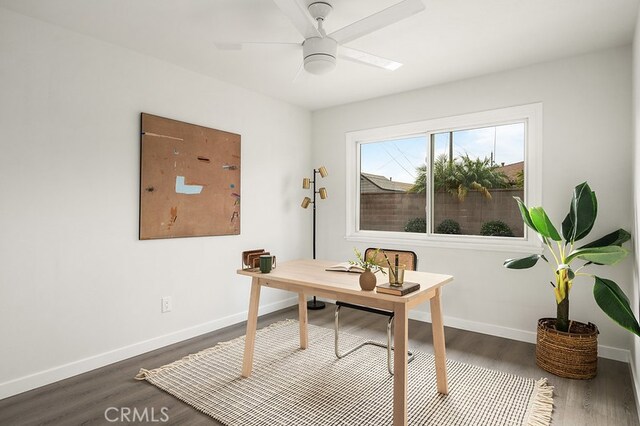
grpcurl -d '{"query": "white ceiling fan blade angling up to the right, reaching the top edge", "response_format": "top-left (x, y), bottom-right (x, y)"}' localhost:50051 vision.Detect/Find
top-left (330, 0), bottom-right (424, 44)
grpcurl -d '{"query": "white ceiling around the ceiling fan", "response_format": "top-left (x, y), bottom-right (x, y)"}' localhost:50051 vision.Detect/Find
top-left (0, 0), bottom-right (640, 110)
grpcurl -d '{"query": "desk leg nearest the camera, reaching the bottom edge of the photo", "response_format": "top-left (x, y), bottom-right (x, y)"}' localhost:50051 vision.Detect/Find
top-left (393, 303), bottom-right (409, 426)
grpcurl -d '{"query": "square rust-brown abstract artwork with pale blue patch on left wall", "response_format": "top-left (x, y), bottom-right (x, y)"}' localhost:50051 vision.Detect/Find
top-left (140, 113), bottom-right (240, 240)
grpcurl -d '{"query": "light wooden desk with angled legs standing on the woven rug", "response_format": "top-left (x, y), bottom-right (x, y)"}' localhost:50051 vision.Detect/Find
top-left (238, 260), bottom-right (453, 426)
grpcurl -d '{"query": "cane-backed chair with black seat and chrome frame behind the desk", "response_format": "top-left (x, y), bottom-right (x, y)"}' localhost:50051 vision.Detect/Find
top-left (334, 248), bottom-right (418, 375)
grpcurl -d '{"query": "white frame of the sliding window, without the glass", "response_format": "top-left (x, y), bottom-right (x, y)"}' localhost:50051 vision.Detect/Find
top-left (345, 103), bottom-right (542, 252)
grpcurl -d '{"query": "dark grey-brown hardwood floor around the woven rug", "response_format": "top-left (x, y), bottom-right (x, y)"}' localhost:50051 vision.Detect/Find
top-left (0, 304), bottom-right (640, 426)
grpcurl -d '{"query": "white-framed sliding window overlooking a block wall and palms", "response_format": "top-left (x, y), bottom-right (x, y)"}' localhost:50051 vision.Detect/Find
top-left (347, 104), bottom-right (542, 250)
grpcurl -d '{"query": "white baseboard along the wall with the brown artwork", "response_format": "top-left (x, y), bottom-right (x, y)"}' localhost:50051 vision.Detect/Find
top-left (0, 297), bottom-right (298, 399)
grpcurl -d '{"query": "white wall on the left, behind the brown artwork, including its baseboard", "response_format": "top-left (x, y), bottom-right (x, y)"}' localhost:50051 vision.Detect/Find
top-left (0, 8), bottom-right (312, 398)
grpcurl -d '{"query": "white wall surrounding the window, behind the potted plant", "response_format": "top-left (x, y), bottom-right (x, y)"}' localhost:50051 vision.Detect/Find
top-left (313, 47), bottom-right (633, 361)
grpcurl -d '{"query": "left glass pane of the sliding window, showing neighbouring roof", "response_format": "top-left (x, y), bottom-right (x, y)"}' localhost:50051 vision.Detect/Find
top-left (359, 135), bottom-right (428, 232)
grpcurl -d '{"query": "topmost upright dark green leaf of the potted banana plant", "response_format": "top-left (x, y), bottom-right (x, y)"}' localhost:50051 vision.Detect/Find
top-left (562, 182), bottom-right (598, 243)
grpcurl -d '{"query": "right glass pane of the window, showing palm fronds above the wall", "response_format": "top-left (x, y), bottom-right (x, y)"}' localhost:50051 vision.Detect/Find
top-left (431, 122), bottom-right (525, 237)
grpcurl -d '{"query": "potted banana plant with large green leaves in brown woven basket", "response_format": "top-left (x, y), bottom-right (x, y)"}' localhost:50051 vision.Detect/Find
top-left (504, 182), bottom-right (640, 379)
